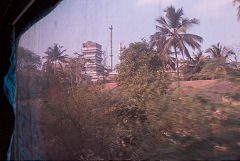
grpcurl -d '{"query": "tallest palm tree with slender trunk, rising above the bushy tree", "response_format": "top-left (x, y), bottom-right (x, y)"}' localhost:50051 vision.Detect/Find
top-left (151, 6), bottom-right (203, 86)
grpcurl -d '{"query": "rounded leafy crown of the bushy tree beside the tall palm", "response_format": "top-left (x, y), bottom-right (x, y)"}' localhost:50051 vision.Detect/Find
top-left (117, 42), bottom-right (170, 103)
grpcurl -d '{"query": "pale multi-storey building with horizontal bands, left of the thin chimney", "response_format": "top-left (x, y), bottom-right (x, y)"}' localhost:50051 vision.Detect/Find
top-left (82, 41), bottom-right (104, 81)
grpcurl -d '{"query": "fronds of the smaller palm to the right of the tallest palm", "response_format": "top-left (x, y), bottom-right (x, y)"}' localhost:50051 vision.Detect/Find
top-left (206, 42), bottom-right (235, 59)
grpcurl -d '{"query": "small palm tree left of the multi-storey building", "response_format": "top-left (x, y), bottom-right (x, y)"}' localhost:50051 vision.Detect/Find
top-left (43, 44), bottom-right (68, 74)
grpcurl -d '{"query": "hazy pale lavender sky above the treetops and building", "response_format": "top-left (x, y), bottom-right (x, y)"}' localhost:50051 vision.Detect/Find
top-left (20, 0), bottom-right (240, 68)
